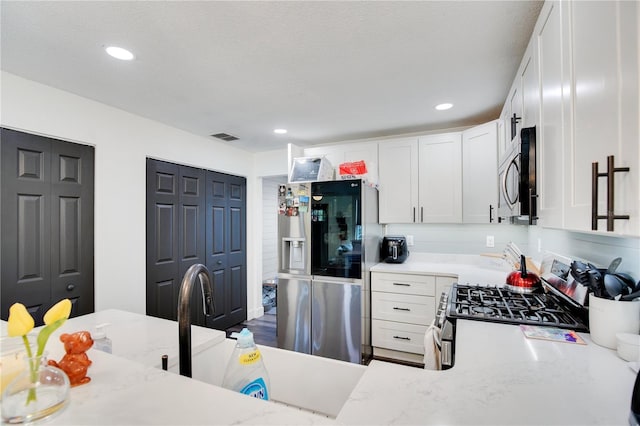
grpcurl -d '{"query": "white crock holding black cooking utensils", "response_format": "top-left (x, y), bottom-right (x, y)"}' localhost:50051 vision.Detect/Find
top-left (589, 293), bottom-right (640, 349)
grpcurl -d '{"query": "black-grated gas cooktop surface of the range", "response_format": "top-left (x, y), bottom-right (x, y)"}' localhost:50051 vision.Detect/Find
top-left (446, 284), bottom-right (588, 331)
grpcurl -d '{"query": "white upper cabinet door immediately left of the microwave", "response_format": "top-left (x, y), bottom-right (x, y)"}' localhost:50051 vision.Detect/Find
top-left (462, 120), bottom-right (499, 223)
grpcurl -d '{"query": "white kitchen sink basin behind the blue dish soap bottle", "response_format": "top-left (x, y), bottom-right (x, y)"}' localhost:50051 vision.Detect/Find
top-left (170, 339), bottom-right (366, 418)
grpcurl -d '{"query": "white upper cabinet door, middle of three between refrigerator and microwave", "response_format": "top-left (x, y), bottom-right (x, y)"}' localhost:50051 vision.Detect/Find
top-left (416, 133), bottom-right (462, 223)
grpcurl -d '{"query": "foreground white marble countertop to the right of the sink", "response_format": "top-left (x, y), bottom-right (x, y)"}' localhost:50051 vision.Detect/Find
top-left (338, 320), bottom-right (636, 425)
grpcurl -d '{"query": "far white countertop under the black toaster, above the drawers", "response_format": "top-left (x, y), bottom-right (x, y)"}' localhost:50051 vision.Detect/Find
top-left (371, 253), bottom-right (513, 286)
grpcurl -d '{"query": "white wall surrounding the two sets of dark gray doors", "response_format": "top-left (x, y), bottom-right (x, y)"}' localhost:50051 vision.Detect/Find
top-left (0, 72), bottom-right (260, 318)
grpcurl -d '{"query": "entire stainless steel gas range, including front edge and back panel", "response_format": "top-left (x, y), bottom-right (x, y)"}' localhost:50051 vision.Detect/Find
top-left (436, 253), bottom-right (589, 369)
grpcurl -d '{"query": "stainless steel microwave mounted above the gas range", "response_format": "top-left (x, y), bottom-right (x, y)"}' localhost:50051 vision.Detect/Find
top-left (498, 127), bottom-right (538, 225)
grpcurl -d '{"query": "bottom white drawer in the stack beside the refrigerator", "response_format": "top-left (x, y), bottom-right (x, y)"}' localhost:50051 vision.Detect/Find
top-left (371, 319), bottom-right (427, 354)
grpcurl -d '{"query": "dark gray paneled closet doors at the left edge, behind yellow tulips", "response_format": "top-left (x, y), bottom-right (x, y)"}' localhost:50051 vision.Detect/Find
top-left (0, 128), bottom-right (95, 325)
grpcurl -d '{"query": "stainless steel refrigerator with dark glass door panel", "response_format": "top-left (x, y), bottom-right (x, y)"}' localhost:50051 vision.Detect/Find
top-left (277, 180), bottom-right (382, 363)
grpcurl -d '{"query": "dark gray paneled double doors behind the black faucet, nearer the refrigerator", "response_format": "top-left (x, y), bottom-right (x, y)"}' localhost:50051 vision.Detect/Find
top-left (147, 159), bottom-right (246, 330)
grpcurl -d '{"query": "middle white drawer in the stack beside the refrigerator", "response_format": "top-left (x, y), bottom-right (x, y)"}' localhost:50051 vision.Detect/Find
top-left (371, 291), bottom-right (436, 325)
